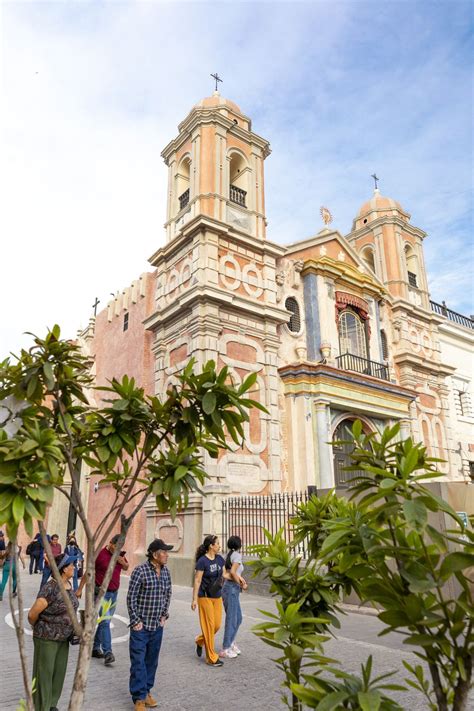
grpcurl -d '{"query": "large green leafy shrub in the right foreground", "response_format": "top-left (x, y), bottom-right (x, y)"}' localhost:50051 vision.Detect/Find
top-left (250, 422), bottom-right (474, 711)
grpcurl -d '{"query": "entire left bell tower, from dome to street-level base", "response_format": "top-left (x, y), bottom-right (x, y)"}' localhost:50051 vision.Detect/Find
top-left (145, 91), bottom-right (288, 555)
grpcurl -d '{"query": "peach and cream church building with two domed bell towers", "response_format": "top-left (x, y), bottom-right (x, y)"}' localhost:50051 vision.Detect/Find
top-left (74, 92), bottom-right (474, 558)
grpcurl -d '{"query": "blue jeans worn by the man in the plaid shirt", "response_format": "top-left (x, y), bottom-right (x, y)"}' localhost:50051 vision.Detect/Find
top-left (129, 627), bottom-right (163, 702)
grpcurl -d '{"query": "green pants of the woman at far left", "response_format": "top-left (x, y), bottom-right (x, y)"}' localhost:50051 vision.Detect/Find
top-left (33, 637), bottom-right (69, 711)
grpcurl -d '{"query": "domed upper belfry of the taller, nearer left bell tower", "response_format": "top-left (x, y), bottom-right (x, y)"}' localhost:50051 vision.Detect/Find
top-left (161, 91), bottom-right (270, 242)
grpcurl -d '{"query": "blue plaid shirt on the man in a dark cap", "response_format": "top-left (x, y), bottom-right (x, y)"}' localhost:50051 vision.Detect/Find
top-left (127, 560), bottom-right (171, 631)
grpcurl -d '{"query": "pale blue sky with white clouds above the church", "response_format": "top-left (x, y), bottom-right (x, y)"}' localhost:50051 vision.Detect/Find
top-left (0, 0), bottom-right (474, 359)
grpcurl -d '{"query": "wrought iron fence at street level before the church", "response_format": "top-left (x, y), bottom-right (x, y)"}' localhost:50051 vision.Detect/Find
top-left (222, 488), bottom-right (316, 557)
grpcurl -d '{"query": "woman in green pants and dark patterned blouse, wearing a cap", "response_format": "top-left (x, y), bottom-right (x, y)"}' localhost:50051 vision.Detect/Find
top-left (28, 555), bottom-right (79, 711)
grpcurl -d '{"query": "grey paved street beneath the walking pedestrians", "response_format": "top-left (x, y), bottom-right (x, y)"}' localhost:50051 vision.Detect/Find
top-left (0, 573), bottom-right (436, 711)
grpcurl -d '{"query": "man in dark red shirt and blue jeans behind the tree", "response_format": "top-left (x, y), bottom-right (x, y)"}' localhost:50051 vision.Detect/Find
top-left (76, 534), bottom-right (129, 667)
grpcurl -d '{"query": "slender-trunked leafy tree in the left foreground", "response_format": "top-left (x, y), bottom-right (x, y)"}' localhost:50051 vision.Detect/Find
top-left (0, 326), bottom-right (265, 711)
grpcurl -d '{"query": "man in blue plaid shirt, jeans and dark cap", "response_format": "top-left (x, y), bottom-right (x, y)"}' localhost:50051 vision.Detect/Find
top-left (127, 538), bottom-right (173, 711)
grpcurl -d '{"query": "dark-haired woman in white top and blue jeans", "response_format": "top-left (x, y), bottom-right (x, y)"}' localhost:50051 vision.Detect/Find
top-left (219, 536), bottom-right (247, 659)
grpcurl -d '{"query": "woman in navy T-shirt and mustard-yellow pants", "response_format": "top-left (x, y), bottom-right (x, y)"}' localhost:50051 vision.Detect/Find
top-left (191, 535), bottom-right (225, 667)
